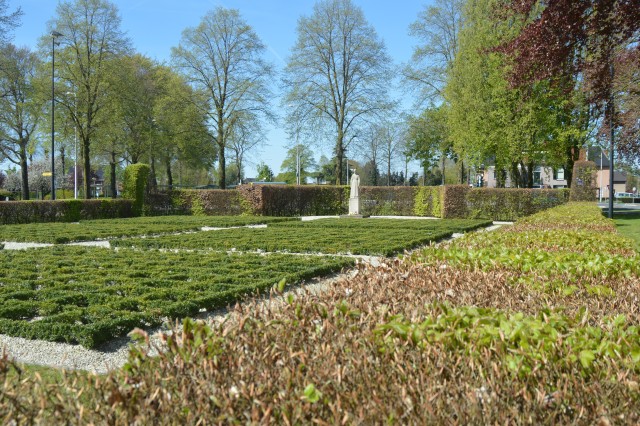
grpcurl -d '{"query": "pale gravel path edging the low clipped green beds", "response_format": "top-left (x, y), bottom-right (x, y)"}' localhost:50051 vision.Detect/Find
top-left (0, 220), bottom-right (509, 373)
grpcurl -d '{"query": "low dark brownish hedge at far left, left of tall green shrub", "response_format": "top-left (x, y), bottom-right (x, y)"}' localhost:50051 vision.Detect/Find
top-left (0, 199), bottom-right (134, 225)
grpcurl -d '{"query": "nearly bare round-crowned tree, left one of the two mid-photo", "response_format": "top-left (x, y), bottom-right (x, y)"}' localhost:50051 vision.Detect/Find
top-left (171, 7), bottom-right (273, 189)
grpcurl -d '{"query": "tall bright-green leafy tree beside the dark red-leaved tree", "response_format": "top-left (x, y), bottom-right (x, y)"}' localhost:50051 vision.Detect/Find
top-left (445, 0), bottom-right (579, 187)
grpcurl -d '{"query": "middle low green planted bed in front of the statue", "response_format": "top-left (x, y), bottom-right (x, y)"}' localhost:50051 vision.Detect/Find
top-left (112, 219), bottom-right (487, 256)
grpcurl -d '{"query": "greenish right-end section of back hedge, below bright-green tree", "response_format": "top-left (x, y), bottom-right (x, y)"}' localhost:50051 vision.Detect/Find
top-left (466, 188), bottom-right (569, 220)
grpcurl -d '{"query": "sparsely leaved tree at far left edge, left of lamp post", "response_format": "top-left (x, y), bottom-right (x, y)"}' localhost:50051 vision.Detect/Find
top-left (0, 44), bottom-right (44, 200)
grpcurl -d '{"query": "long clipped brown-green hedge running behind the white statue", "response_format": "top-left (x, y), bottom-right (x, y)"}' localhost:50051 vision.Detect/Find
top-left (145, 185), bottom-right (569, 220)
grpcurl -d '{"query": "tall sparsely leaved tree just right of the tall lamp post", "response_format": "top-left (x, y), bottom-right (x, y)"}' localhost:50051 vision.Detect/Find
top-left (47, 0), bottom-right (129, 198)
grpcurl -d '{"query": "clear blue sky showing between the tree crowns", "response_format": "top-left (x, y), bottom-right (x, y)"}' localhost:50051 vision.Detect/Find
top-left (8, 0), bottom-right (431, 177)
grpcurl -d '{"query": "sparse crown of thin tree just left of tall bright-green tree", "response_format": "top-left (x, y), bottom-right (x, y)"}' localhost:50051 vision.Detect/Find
top-left (402, 0), bottom-right (465, 104)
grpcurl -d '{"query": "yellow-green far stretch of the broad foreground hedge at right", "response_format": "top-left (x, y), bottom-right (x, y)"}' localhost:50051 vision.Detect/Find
top-left (417, 202), bottom-right (640, 290)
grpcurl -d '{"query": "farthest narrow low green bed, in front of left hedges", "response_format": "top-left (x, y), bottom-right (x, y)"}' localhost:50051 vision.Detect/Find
top-left (0, 216), bottom-right (299, 244)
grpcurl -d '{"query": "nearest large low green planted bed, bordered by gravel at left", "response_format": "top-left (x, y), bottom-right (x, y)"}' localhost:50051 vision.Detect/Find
top-left (0, 246), bottom-right (353, 347)
